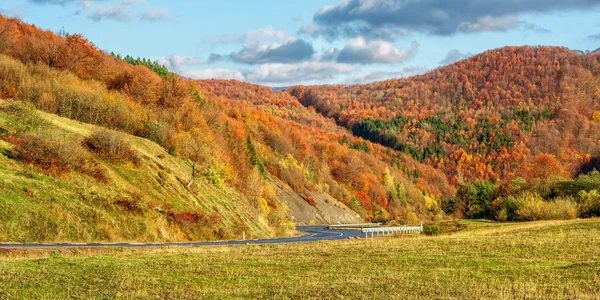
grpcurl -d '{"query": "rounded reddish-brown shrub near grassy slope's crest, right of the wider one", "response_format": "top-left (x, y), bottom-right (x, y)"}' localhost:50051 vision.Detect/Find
top-left (84, 130), bottom-right (141, 166)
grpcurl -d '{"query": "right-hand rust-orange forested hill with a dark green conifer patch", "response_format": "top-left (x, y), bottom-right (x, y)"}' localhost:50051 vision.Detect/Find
top-left (288, 47), bottom-right (600, 183)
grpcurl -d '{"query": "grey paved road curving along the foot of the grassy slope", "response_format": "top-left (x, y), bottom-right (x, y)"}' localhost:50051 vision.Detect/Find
top-left (0, 226), bottom-right (363, 248)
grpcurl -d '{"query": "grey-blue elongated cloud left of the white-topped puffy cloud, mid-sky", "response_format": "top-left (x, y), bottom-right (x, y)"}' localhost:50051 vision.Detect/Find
top-left (218, 39), bottom-right (315, 65)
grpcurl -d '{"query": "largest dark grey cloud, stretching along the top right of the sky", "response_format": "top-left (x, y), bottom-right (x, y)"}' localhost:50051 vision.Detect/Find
top-left (300, 0), bottom-right (600, 38)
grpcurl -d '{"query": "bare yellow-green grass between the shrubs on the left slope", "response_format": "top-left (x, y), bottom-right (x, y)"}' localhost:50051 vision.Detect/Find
top-left (0, 103), bottom-right (273, 242)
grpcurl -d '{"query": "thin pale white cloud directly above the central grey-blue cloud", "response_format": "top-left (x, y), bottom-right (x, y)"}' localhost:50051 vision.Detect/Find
top-left (204, 26), bottom-right (291, 44)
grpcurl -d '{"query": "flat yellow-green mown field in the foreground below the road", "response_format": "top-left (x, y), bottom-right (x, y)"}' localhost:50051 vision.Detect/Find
top-left (0, 219), bottom-right (600, 299)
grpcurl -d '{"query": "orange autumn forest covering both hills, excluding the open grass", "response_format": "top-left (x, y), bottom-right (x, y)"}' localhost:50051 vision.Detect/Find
top-left (0, 13), bottom-right (600, 239)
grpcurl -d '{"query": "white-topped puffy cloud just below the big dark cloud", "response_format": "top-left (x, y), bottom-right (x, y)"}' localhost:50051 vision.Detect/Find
top-left (337, 37), bottom-right (419, 64)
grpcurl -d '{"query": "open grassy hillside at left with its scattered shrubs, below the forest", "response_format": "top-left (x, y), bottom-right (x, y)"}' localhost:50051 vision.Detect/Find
top-left (0, 102), bottom-right (282, 242)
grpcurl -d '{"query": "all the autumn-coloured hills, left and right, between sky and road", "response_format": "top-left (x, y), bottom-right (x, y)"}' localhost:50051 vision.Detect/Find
top-left (0, 16), bottom-right (600, 241)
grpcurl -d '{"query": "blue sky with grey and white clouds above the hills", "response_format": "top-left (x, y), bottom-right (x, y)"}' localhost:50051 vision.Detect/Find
top-left (0, 0), bottom-right (600, 87)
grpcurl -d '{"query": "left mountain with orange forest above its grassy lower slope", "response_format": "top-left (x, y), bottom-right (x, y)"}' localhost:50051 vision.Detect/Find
top-left (0, 17), bottom-right (446, 241)
